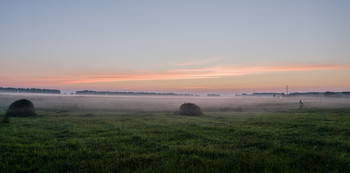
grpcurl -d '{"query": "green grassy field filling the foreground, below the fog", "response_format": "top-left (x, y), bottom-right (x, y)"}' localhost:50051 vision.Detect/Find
top-left (0, 109), bottom-right (350, 172)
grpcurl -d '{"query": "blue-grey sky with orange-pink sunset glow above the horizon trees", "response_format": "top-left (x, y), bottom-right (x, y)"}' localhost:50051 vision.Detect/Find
top-left (0, 0), bottom-right (350, 93)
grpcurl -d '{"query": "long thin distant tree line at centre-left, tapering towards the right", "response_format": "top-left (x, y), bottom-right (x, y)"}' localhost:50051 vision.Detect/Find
top-left (75, 90), bottom-right (193, 96)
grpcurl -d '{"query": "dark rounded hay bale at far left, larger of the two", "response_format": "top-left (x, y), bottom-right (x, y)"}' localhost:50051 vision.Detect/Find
top-left (6, 99), bottom-right (37, 117)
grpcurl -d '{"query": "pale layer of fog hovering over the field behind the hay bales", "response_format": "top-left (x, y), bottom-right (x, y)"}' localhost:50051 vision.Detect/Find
top-left (0, 94), bottom-right (350, 112)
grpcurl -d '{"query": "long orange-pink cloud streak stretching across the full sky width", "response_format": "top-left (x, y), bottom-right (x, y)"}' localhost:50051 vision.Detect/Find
top-left (0, 65), bottom-right (350, 85)
